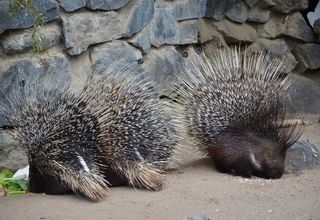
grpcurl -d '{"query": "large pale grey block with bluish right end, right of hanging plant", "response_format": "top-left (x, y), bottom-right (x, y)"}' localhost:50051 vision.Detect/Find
top-left (62, 0), bottom-right (154, 55)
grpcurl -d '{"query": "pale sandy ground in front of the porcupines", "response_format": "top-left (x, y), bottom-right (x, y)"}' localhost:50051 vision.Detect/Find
top-left (0, 116), bottom-right (320, 220)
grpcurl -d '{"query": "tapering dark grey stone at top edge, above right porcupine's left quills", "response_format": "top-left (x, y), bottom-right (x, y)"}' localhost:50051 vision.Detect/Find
top-left (205, 0), bottom-right (235, 20)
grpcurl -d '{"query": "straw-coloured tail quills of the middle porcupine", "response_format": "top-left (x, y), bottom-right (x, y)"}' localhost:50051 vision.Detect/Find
top-left (127, 161), bottom-right (164, 191)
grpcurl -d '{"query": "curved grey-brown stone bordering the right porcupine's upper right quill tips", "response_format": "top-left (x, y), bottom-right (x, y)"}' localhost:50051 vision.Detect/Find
top-left (248, 38), bottom-right (297, 73)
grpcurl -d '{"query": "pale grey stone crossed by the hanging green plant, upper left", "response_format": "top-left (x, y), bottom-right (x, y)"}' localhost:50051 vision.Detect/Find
top-left (0, 23), bottom-right (61, 54)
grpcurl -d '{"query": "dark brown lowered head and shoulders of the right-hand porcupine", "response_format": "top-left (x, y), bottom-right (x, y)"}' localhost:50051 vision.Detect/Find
top-left (208, 132), bottom-right (285, 179)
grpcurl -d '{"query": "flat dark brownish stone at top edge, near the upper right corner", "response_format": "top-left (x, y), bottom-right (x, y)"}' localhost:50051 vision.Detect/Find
top-left (272, 0), bottom-right (309, 13)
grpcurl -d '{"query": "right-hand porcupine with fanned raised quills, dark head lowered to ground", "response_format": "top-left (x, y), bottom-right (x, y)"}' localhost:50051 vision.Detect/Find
top-left (178, 47), bottom-right (301, 178)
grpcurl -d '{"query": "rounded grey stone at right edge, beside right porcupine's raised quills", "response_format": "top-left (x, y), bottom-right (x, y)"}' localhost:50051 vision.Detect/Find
top-left (288, 75), bottom-right (320, 114)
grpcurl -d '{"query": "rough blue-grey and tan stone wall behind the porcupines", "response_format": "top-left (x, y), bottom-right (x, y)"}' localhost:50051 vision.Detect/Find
top-left (0, 0), bottom-right (320, 168)
